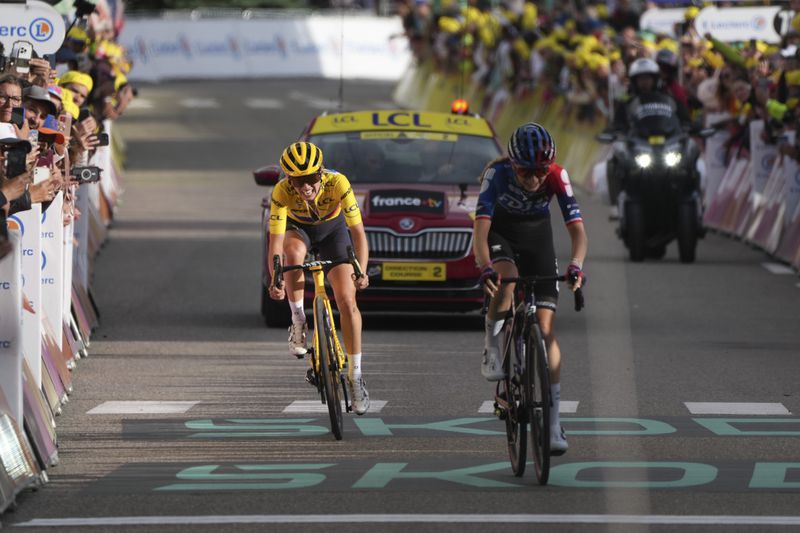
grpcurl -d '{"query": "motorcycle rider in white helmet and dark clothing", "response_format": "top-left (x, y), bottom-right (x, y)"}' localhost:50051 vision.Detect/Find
top-left (606, 58), bottom-right (691, 218)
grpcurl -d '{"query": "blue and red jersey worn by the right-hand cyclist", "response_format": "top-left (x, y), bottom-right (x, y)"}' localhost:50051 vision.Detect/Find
top-left (475, 161), bottom-right (583, 225)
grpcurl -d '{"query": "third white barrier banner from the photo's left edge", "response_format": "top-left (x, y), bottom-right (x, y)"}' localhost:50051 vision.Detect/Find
top-left (40, 192), bottom-right (64, 346)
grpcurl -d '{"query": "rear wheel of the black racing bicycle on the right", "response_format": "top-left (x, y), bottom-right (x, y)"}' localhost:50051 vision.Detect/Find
top-left (502, 314), bottom-right (528, 477)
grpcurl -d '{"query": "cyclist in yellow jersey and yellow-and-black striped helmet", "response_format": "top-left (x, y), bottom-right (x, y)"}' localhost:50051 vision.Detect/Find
top-left (267, 142), bottom-right (369, 415)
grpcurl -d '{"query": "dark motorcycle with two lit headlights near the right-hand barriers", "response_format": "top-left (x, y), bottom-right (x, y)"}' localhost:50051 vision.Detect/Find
top-left (596, 116), bottom-right (715, 263)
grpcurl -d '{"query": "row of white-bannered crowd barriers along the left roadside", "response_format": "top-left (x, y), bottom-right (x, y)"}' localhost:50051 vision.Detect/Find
top-left (0, 122), bottom-right (122, 513)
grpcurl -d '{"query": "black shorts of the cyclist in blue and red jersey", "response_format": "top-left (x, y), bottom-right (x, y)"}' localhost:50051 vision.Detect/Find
top-left (489, 217), bottom-right (558, 311)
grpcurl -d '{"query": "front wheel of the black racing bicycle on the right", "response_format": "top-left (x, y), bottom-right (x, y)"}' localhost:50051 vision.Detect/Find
top-left (525, 323), bottom-right (550, 485)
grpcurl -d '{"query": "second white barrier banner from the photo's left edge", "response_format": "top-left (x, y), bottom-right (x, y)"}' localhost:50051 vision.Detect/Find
top-left (8, 204), bottom-right (42, 387)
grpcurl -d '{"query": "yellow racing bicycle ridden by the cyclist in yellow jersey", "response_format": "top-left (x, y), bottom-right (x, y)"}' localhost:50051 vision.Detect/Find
top-left (272, 247), bottom-right (364, 440)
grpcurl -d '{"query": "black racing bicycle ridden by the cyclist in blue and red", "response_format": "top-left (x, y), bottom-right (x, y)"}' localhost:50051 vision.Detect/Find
top-left (484, 276), bottom-right (585, 485)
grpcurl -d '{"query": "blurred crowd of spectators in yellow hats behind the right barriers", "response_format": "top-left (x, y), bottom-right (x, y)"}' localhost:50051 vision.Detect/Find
top-left (399, 0), bottom-right (800, 163)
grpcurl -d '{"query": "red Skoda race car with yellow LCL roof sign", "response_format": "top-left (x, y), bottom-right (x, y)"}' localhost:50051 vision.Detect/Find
top-left (254, 110), bottom-right (501, 326)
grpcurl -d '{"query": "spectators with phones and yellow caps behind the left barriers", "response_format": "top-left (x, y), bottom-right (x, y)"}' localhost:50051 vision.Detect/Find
top-left (0, 0), bottom-right (135, 259)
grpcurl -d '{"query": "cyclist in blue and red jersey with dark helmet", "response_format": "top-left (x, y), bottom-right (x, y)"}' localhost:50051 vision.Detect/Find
top-left (473, 122), bottom-right (588, 453)
